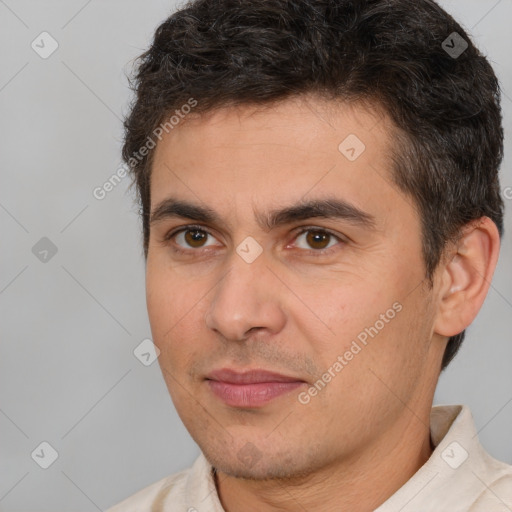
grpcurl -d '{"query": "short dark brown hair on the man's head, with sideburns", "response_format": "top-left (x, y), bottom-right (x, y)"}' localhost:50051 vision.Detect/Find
top-left (122, 0), bottom-right (503, 369)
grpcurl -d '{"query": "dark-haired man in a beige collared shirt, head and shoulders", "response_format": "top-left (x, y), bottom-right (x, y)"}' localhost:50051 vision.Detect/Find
top-left (106, 0), bottom-right (512, 512)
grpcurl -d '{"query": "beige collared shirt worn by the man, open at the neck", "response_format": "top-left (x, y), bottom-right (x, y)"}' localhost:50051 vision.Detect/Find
top-left (106, 405), bottom-right (512, 512)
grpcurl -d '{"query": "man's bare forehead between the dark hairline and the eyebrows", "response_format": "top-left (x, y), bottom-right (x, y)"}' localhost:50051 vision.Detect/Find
top-left (151, 98), bottom-right (403, 230)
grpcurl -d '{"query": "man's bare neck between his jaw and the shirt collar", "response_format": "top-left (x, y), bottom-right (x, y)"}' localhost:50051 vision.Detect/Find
top-left (215, 410), bottom-right (433, 512)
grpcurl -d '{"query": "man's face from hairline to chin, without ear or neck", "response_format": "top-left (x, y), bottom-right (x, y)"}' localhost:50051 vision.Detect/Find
top-left (146, 99), bottom-right (440, 478)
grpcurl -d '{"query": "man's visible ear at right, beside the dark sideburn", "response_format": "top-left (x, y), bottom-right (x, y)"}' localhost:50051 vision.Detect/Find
top-left (434, 217), bottom-right (500, 337)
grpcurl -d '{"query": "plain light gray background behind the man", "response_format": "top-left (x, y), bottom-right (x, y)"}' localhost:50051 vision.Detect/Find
top-left (0, 0), bottom-right (512, 512)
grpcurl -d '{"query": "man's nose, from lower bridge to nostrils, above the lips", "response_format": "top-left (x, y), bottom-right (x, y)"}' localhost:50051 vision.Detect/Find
top-left (205, 249), bottom-right (286, 341)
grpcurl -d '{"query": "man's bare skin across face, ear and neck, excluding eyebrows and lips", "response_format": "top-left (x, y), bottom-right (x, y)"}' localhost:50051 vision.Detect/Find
top-left (146, 97), bottom-right (499, 512)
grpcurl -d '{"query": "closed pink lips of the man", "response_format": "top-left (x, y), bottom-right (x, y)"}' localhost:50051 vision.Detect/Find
top-left (206, 368), bottom-right (305, 408)
